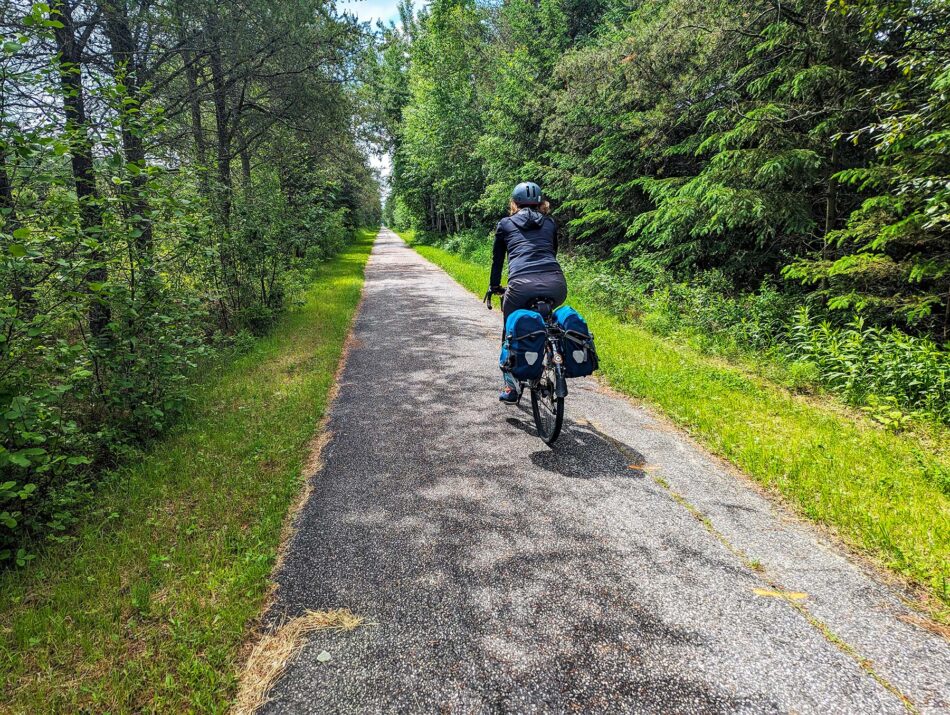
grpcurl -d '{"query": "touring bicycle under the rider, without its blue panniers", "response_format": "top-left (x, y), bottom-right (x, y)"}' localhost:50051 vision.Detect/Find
top-left (485, 288), bottom-right (567, 446)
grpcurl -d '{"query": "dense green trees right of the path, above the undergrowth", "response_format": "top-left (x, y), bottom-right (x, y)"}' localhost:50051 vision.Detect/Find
top-left (377, 0), bottom-right (950, 342)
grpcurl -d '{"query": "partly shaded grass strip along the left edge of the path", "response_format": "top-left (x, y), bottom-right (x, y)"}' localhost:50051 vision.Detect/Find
top-left (0, 231), bottom-right (374, 713)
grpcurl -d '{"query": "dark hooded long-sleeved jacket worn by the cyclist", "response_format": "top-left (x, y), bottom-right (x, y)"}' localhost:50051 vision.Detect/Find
top-left (490, 208), bottom-right (561, 286)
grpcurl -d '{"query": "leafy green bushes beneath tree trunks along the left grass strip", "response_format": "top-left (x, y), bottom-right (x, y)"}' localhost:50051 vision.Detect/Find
top-left (0, 171), bottom-right (366, 565)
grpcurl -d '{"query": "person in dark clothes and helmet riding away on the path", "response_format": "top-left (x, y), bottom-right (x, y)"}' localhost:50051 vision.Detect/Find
top-left (489, 181), bottom-right (567, 404)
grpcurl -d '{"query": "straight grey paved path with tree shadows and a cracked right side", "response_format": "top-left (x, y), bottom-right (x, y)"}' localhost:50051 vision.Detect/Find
top-left (265, 231), bottom-right (950, 713)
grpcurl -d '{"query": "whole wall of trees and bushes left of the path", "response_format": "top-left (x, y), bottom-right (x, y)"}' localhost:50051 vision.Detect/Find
top-left (0, 0), bottom-right (380, 569)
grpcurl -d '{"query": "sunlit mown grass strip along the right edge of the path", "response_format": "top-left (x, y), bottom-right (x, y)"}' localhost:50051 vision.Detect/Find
top-left (409, 236), bottom-right (950, 621)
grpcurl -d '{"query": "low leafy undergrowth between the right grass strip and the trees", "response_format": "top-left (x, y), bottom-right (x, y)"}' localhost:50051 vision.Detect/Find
top-left (430, 230), bottom-right (950, 430)
